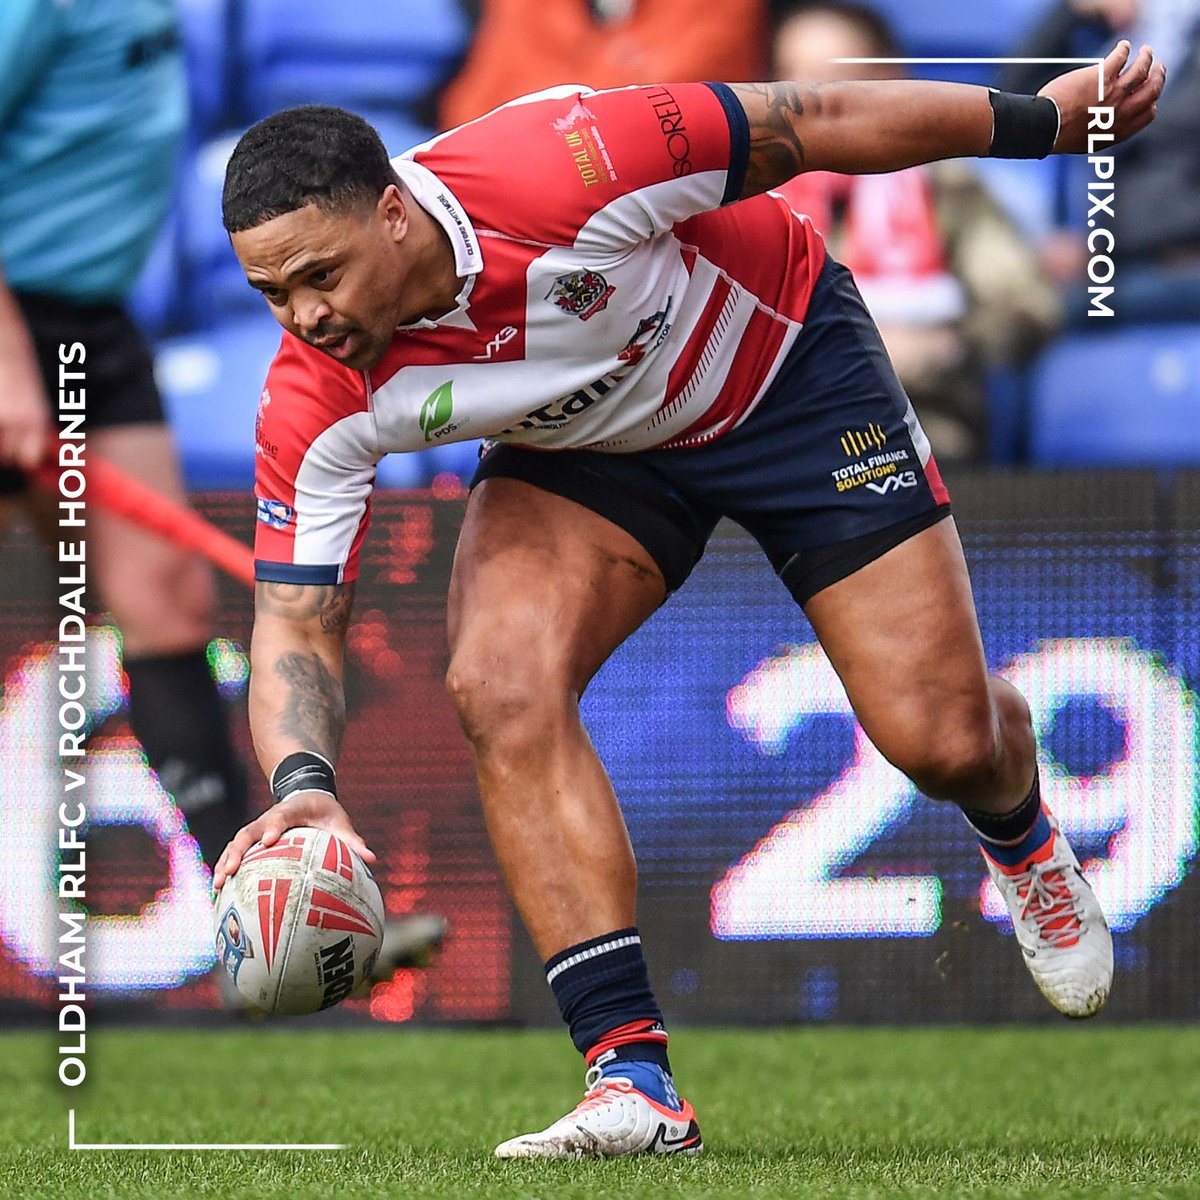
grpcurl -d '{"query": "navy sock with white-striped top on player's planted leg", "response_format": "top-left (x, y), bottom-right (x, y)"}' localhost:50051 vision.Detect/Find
top-left (546, 926), bottom-right (671, 1075)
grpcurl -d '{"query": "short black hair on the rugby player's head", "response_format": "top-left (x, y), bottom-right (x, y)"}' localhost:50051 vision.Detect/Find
top-left (221, 104), bottom-right (400, 233)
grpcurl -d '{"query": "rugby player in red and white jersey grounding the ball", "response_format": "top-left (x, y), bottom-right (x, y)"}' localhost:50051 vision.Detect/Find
top-left (216, 42), bottom-right (1165, 1157)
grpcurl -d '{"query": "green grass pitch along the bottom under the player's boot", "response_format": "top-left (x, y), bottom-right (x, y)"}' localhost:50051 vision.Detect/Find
top-left (0, 1024), bottom-right (1200, 1200)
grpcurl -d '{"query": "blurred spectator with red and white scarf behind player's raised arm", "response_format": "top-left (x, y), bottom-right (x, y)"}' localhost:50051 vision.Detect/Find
top-left (773, 0), bottom-right (1060, 461)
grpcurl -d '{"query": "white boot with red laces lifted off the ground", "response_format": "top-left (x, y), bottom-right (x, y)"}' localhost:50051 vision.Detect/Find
top-left (980, 810), bottom-right (1112, 1016)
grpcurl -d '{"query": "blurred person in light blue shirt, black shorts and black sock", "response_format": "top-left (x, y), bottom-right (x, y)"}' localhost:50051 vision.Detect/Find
top-left (0, 0), bottom-right (247, 864)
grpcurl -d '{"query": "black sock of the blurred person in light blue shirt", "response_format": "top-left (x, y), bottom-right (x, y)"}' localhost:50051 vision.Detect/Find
top-left (124, 649), bottom-right (248, 866)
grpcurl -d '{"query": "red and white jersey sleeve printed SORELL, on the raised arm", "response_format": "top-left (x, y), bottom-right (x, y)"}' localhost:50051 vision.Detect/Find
top-left (414, 83), bottom-right (750, 251)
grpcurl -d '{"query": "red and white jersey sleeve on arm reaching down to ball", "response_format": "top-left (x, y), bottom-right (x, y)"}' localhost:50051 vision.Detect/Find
top-left (254, 334), bottom-right (380, 583)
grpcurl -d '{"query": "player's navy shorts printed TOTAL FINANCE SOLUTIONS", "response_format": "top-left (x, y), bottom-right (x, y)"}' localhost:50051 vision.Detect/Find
top-left (472, 259), bottom-right (950, 604)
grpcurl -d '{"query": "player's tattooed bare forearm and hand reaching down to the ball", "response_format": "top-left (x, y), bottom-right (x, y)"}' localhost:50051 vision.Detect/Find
top-left (212, 582), bottom-right (376, 889)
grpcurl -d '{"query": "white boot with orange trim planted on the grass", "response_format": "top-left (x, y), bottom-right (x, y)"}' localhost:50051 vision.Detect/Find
top-left (496, 1067), bottom-right (704, 1158)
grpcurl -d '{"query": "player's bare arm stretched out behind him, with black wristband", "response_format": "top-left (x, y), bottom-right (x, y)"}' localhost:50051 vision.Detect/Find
top-left (731, 42), bottom-right (1166, 198)
